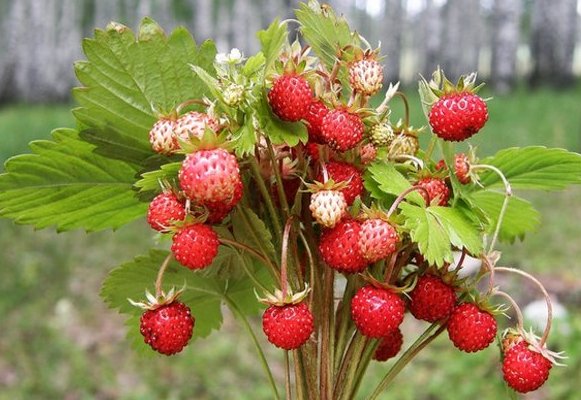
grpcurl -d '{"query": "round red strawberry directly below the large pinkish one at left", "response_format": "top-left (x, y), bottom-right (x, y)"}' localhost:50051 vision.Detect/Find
top-left (171, 224), bottom-right (220, 269)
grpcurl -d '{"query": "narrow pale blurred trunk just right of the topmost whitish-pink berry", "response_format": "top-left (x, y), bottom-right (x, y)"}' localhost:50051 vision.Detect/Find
top-left (380, 0), bottom-right (405, 82)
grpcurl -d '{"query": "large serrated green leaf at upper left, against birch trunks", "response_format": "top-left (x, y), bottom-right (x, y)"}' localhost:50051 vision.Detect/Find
top-left (73, 18), bottom-right (216, 162)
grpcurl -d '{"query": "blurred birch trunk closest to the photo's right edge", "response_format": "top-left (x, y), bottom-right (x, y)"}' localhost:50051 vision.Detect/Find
top-left (530, 0), bottom-right (577, 86)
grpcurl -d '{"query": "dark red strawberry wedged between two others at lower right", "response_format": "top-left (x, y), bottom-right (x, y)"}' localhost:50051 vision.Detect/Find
top-left (410, 275), bottom-right (456, 322)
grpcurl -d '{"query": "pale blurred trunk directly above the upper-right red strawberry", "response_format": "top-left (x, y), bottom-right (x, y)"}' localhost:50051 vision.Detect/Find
top-left (441, 0), bottom-right (482, 81)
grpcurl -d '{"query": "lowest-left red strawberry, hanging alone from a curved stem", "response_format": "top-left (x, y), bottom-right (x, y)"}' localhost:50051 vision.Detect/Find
top-left (139, 301), bottom-right (195, 356)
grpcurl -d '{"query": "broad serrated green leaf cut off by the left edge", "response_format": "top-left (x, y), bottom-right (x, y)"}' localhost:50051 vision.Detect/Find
top-left (0, 129), bottom-right (147, 231)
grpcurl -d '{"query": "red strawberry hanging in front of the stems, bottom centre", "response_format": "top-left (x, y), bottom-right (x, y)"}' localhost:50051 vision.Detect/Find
top-left (262, 303), bottom-right (315, 350)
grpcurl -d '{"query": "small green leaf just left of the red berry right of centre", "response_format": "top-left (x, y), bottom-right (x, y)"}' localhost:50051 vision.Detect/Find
top-left (363, 161), bottom-right (426, 205)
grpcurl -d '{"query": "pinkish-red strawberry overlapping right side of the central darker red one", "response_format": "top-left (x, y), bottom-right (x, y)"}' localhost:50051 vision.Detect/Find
top-left (359, 218), bottom-right (399, 263)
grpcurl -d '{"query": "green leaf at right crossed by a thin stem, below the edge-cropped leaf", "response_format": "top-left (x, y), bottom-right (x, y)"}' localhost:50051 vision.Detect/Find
top-left (468, 190), bottom-right (541, 242)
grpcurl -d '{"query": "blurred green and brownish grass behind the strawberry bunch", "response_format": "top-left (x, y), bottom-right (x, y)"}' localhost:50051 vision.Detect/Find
top-left (0, 87), bottom-right (581, 400)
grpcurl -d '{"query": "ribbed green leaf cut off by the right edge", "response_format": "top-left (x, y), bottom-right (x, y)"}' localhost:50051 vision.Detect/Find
top-left (480, 146), bottom-right (581, 190)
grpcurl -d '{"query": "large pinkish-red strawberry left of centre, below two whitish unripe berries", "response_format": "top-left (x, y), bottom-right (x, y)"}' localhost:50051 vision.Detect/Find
top-left (178, 149), bottom-right (241, 205)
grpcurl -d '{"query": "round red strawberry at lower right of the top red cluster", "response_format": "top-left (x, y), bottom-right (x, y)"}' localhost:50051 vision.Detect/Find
top-left (321, 108), bottom-right (365, 151)
